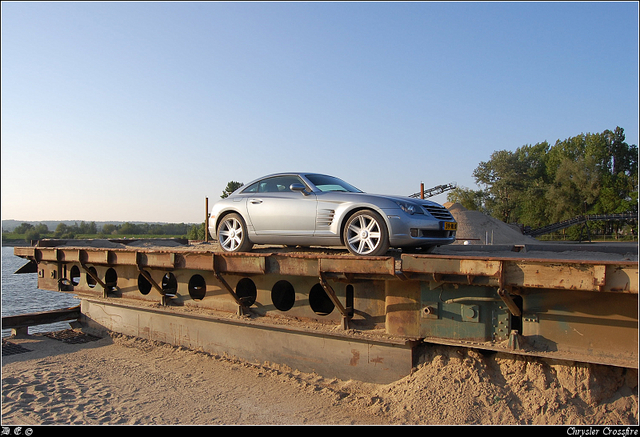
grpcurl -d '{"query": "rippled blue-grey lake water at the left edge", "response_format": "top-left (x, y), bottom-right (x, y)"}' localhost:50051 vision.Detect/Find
top-left (0, 247), bottom-right (80, 337)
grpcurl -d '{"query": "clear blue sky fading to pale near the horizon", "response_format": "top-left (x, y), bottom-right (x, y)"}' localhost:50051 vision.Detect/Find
top-left (1, 2), bottom-right (638, 223)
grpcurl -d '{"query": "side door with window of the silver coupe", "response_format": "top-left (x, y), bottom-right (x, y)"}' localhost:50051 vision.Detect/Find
top-left (247, 176), bottom-right (317, 238)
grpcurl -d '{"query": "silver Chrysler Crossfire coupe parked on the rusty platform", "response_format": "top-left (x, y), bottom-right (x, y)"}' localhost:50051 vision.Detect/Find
top-left (209, 173), bottom-right (457, 256)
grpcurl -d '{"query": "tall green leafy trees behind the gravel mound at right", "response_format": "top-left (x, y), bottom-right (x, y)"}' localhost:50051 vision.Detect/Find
top-left (448, 127), bottom-right (638, 238)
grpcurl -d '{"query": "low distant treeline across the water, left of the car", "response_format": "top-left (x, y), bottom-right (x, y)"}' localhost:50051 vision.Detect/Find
top-left (2, 221), bottom-right (204, 241)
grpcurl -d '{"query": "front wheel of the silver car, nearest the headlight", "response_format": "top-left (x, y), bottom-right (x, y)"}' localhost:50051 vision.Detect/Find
top-left (343, 210), bottom-right (389, 256)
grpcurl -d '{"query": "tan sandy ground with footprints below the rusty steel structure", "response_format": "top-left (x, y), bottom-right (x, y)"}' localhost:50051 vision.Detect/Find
top-left (2, 333), bottom-right (638, 425)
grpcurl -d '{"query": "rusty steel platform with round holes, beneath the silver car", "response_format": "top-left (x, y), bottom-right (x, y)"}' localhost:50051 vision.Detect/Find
top-left (14, 240), bottom-right (638, 383)
